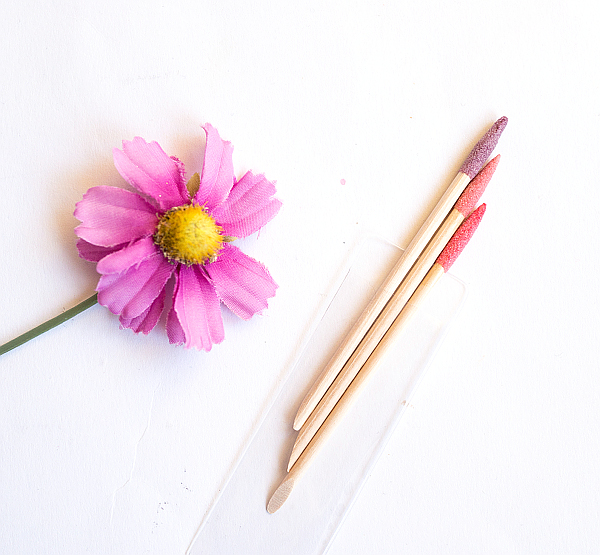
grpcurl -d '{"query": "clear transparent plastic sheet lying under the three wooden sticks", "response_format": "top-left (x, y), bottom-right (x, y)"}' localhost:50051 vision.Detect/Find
top-left (188, 239), bottom-right (465, 555)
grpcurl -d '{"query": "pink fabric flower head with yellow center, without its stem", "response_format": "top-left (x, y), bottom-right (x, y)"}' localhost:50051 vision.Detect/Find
top-left (75, 124), bottom-right (281, 351)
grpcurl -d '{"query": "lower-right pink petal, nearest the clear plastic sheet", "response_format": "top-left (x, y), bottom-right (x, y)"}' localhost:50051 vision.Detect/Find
top-left (206, 245), bottom-right (277, 320)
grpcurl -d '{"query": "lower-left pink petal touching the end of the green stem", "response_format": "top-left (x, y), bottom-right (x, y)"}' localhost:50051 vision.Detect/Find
top-left (96, 252), bottom-right (174, 320)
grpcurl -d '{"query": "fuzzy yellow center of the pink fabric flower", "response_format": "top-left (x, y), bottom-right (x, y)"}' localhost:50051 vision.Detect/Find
top-left (154, 204), bottom-right (225, 266)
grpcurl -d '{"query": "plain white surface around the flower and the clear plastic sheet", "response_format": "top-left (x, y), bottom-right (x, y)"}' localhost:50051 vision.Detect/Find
top-left (0, 0), bottom-right (600, 555)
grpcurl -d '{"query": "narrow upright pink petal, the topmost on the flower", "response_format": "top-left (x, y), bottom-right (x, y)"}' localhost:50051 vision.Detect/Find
top-left (194, 123), bottom-right (233, 210)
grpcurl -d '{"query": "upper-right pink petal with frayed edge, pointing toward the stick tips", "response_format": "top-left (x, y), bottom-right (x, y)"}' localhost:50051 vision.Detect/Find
top-left (212, 172), bottom-right (281, 237)
